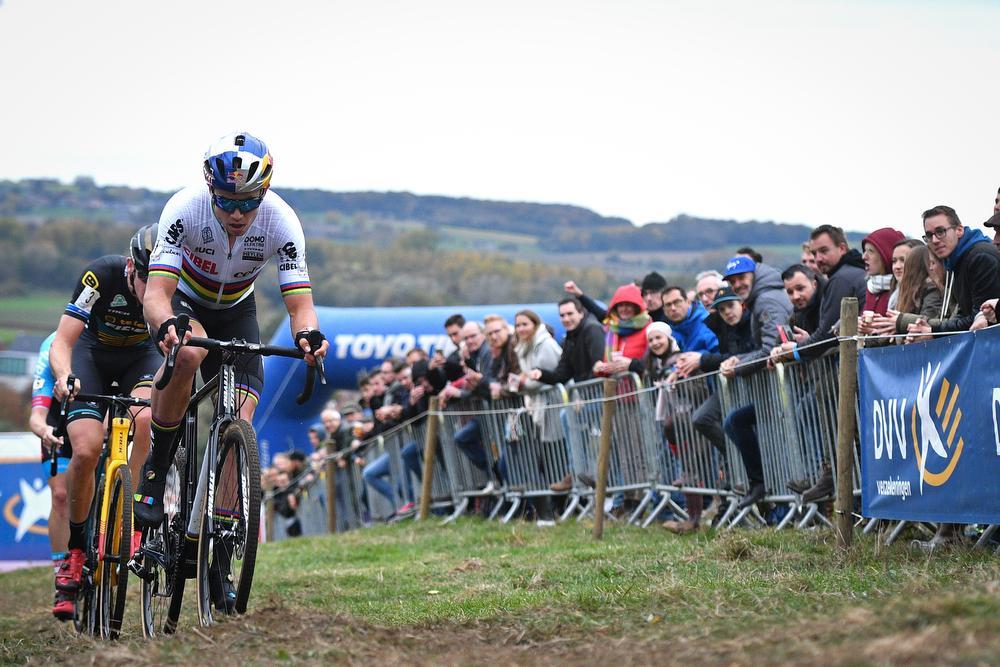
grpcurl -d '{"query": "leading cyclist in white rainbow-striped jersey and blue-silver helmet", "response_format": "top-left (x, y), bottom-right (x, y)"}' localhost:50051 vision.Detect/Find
top-left (135, 132), bottom-right (329, 608)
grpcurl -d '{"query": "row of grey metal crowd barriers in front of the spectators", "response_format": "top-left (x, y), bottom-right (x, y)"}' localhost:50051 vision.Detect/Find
top-left (270, 354), bottom-right (900, 539)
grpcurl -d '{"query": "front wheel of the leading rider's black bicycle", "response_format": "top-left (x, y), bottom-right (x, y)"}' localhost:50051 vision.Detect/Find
top-left (198, 419), bottom-right (260, 625)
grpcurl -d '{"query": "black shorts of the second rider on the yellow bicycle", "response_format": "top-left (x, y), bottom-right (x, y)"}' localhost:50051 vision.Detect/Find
top-left (66, 331), bottom-right (163, 423)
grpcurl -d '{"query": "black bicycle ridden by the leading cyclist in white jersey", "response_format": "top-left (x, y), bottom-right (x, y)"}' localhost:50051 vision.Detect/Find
top-left (129, 315), bottom-right (326, 637)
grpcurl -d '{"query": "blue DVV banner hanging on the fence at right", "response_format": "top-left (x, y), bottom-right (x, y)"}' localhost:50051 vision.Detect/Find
top-left (858, 327), bottom-right (1000, 523)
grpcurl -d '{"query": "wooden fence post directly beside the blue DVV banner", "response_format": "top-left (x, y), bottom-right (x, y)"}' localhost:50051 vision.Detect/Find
top-left (833, 297), bottom-right (858, 549)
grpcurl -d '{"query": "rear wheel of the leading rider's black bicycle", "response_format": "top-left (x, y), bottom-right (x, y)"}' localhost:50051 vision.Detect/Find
top-left (139, 459), bottom-right (184, 639)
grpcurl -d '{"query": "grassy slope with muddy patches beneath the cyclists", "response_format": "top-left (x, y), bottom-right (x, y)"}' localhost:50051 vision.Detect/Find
top-left (0, 520), bottom-right (1000, 666)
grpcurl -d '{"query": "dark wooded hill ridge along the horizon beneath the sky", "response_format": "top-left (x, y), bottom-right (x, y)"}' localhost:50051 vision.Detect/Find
top-left (0, 177), bottom-right (862, 253)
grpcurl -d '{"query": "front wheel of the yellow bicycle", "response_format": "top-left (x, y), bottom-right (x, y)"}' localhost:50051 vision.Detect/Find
top-left (98, 465), bottom-right (132, 639)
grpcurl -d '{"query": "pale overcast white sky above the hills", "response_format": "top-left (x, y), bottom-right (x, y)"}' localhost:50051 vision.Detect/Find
top-left (0, 0), bottom-right (1000, 235)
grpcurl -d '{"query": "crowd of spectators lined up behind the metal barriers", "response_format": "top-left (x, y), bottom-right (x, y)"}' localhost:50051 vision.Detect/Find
top-left (265, 192), bottom-right (1000, 542)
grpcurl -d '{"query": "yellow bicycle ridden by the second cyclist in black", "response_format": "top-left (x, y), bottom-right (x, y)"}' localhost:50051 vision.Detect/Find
top-left (50, 386), bottom-right (149, 639)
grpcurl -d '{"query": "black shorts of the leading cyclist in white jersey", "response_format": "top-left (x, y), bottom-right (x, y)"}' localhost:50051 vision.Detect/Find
top-left (172, 290), bottom-right (264, 403)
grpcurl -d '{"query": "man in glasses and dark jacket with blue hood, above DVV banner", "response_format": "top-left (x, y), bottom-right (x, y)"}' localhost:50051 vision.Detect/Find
top-left (908, 206), bottom-right (1000, 334)
